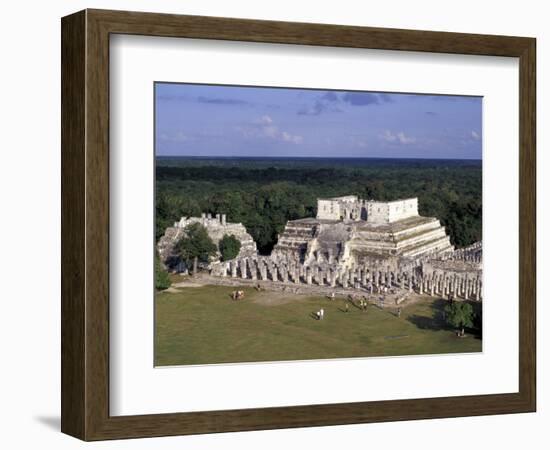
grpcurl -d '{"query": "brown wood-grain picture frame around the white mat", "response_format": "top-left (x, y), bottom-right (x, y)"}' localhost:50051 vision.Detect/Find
top-left (61, 10), bottom-right (536, 440)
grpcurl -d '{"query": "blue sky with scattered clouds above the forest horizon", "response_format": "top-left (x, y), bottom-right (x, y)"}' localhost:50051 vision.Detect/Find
top-left (155, 83), bottom-right (482, 159)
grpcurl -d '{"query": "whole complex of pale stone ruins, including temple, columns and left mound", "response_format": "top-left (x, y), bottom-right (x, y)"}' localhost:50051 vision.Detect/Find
top-left (158, 195), bottom-right (482, 304)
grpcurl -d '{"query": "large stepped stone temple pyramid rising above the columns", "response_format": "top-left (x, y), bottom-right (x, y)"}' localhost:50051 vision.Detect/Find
top-left (272, 195), bottom-right (453, 267)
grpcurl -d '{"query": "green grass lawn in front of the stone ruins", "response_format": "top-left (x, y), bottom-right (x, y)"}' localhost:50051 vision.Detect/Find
top-left (155, 286), bottom-right (482, 366)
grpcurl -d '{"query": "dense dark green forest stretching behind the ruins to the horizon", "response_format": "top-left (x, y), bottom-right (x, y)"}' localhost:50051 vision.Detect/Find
top-left (156, 158), bottom-right (482, 254)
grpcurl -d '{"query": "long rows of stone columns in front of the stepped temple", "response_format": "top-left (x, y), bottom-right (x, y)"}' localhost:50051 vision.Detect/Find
top-left (210, 250), bottom-right (483, 306)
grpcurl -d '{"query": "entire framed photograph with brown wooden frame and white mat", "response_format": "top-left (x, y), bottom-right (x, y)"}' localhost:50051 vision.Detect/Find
top-left (62, 10), bottom-right (536, 440)
